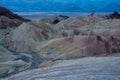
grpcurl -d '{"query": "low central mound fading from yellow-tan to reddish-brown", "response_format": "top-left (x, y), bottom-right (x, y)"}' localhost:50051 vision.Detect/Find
top-left (36, 36), bottom-right (109, 60)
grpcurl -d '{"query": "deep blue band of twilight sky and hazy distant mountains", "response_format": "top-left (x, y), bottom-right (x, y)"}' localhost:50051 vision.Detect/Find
top-left (0, 0), bottom-right (120, 12)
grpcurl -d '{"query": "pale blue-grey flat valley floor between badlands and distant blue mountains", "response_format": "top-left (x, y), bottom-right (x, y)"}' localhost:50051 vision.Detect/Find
top-left (16, 12), bottom-right (113, 20)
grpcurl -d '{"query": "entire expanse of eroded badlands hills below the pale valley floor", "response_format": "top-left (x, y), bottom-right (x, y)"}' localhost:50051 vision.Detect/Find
top-left (0, 7), bottom-right (120, 80)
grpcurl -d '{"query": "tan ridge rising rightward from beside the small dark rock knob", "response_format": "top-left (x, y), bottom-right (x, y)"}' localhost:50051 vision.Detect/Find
top-left (55, 14), bottom-right (106, 31)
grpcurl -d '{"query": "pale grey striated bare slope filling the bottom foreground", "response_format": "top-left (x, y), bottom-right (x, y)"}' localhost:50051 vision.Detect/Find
top-left (5, 57), bottom-right (120, 80)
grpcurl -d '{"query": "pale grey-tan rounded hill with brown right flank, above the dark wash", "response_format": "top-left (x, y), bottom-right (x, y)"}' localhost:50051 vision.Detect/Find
top-left (8, 22), bottom-right (56, 52)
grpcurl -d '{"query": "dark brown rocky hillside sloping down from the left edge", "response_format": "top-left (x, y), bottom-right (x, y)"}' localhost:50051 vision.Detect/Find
top-left (0, 7), bottom-right (30, 29)
